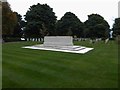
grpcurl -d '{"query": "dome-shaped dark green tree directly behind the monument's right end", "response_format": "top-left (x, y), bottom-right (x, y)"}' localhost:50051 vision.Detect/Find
top-left (56, 12), bottom-right (83, 37)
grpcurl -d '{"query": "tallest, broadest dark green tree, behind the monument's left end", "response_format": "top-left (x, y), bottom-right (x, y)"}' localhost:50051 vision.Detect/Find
top-left (25, 3), bottom-right (56, 37)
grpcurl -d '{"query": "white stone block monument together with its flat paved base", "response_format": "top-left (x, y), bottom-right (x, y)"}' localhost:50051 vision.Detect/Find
top-left (22, 36), bottom-right (93, 54)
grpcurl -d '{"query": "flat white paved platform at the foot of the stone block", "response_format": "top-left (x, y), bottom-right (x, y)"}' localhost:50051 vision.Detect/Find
top-left (22, 44), bottom-right (93, 54)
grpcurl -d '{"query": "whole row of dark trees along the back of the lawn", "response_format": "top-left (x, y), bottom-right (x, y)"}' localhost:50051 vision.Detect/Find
top-left (2, 2), bottom-right (120, 40)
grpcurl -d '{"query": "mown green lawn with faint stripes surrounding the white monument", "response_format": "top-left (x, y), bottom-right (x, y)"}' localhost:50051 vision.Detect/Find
top-left (2, 41), bottom-right (118, 88)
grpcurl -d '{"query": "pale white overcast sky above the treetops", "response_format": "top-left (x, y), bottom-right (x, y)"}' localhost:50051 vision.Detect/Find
top-left (7, 0), bottom-right (120, 27)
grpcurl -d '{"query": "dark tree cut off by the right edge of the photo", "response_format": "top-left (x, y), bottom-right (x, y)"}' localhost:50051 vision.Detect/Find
top-left (112, 18), bottom-right (120, 36)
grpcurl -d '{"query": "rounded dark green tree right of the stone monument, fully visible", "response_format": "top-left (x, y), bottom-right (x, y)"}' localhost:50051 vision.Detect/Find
top-left (85, 14), bottom-right (110, 38)
